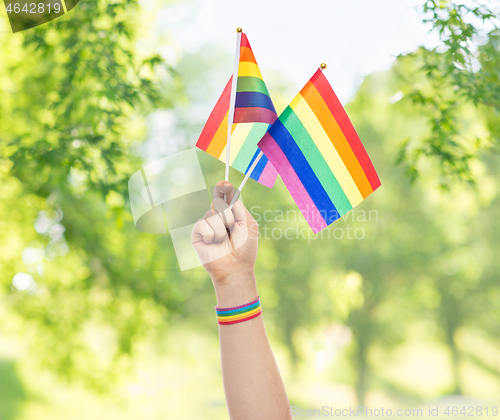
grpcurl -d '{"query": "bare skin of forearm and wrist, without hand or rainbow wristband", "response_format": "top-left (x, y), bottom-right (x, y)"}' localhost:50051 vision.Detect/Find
top-left (215, 272), bottom-right (291, 420)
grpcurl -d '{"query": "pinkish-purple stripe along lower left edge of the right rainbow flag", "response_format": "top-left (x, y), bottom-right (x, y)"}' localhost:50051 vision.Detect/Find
top-left (258, 132), bottom-right (327, 233)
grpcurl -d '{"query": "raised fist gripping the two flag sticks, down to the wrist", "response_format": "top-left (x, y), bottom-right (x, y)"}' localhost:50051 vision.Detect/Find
top-left (192, 181), bottom-right (259, 291)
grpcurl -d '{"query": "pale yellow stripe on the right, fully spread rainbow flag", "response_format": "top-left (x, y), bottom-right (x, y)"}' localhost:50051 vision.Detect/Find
top-left (290, 93), bottom-right (363, 207)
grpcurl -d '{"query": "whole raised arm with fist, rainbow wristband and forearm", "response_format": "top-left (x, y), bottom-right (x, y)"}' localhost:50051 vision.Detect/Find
top-left (192, 181), bottom-right (291, 420)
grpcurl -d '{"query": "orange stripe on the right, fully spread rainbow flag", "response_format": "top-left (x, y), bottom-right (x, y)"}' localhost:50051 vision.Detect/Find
top-left (300, 81), bottom-right (373, 198)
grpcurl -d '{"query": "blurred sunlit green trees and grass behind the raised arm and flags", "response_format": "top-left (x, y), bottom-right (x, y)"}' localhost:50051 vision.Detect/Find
top-left (0, 0), bottom-right (500, 420)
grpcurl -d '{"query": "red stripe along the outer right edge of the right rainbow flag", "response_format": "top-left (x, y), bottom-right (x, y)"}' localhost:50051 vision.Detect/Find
top-left (311, 69), bottom-right (381, 191)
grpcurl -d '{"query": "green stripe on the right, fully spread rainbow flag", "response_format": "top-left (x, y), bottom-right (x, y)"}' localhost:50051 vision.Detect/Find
top-left (280, 107), bottom-right (352, 216)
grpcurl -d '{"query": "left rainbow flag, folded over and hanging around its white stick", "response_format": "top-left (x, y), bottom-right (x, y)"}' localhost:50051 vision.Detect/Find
top-left (196, 33), bottom-right (278, 188)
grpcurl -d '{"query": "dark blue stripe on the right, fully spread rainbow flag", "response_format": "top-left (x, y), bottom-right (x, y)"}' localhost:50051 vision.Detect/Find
top-left (269, 119), bottom-right (340, 225)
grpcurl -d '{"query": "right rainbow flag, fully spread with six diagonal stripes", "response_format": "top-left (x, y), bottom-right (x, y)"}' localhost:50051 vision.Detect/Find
top-left (258, 69), bottom-right (380, 233)
